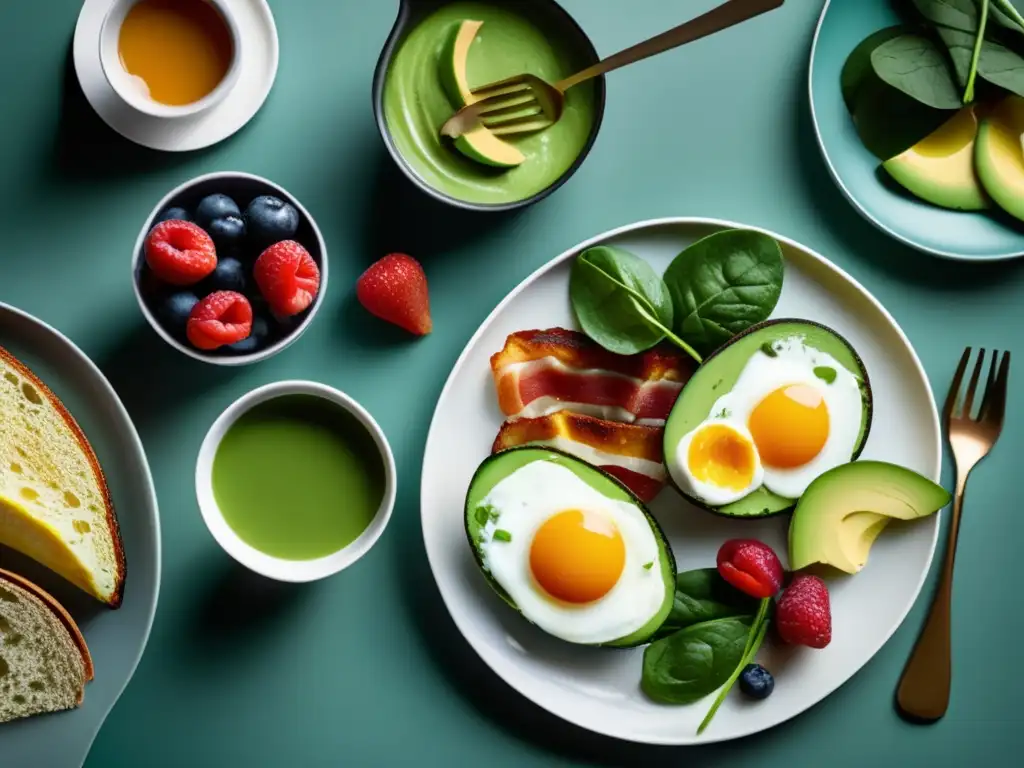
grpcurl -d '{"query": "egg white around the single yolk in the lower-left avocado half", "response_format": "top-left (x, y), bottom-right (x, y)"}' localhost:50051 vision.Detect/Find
top-left (478, 460), bottom-right (666, 644)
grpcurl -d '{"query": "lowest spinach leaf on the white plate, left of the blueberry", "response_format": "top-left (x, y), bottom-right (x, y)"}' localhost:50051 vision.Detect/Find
top-left (640, 616), bottom-right (754, 703)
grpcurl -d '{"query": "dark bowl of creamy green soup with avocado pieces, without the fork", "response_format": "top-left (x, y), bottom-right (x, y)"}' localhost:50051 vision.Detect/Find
top-left (373, 0), bottom-right (605, 211)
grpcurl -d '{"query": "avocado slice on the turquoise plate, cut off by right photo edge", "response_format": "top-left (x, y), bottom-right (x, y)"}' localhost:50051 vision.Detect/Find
top-left (975, 96), bottom-right (1024, 220)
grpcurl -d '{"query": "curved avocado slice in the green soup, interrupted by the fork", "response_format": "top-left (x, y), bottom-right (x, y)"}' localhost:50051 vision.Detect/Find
top-left (440, 19), bottom-right (526, 168)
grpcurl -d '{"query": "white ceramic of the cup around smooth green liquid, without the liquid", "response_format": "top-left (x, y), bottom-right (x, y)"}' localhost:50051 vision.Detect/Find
top-left (196, 381), bottom-right (397, 582)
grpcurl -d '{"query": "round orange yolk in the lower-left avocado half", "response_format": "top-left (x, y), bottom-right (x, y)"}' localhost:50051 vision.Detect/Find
top-left (529, 509), bottom-right (626, 604)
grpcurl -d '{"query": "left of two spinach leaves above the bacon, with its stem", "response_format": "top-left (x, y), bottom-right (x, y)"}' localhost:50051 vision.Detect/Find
top-left (569, 246), bottom-right (700, 362)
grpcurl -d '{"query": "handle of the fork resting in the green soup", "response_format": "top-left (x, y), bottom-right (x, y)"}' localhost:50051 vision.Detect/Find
top-left (555, 0), bottom-right (785, 93)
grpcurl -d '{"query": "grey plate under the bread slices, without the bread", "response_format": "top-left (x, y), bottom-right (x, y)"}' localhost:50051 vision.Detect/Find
top-left (0, 302), bottom-right (160, 768)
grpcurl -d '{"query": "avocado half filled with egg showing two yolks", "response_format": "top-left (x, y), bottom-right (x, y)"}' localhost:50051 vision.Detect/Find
top-left (665, 319), bottom-right (871, 517)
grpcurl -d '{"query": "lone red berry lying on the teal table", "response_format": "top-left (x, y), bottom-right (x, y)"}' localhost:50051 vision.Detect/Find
top-left (355, 253), bottom-right (433, 336)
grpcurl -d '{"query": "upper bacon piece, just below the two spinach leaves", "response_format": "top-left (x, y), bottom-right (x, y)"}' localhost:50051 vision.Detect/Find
top-left (490, 328), bottom-right (695, 426)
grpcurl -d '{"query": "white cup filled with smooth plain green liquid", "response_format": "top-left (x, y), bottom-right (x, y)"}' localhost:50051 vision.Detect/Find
top-left (196, 381), bottom-right (397, 583)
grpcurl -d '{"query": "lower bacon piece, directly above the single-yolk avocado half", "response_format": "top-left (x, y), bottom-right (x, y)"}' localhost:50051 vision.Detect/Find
top-left (492, 411), bottom-right (666, 502)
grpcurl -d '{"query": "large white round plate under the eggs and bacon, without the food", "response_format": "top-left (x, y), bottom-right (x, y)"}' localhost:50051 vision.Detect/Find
top-left (421, 218), bottom-right (942, 744)
